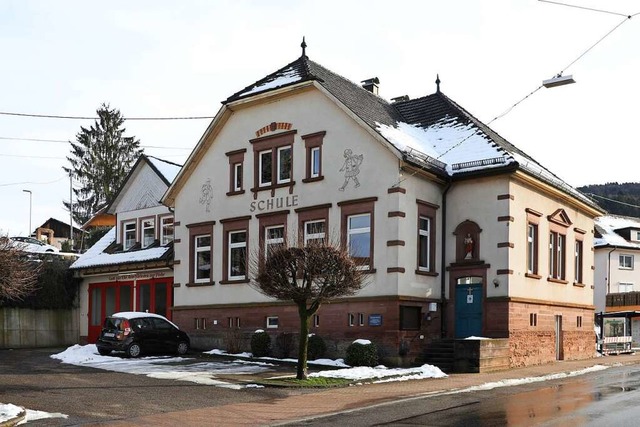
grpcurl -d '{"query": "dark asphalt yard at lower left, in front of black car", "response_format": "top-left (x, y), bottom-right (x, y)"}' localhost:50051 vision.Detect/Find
top-left (0, 349), bottom-right (292, 426)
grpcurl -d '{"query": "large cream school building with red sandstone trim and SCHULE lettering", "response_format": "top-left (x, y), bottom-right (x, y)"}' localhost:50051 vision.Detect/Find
top-left (163, 43), bottom-right (603, 366)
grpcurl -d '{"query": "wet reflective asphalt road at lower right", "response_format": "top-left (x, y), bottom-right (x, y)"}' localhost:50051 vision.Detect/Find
top-left (282, 365), bottom-right (640, 427)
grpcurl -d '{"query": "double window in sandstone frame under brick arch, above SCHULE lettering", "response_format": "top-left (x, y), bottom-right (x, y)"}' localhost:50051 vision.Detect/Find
top-left (250, 131), bottom-right (296, 192)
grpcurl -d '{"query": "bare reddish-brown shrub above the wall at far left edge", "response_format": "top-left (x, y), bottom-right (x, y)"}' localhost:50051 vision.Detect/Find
top-left (0, 236), bottom-right (40, 303)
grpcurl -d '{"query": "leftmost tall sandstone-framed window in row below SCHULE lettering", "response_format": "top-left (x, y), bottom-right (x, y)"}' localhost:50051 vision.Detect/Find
top-left (186, 222), bottom-right (215, 286)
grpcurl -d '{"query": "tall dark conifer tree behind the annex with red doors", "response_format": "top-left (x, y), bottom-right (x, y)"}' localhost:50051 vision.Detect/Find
top-left (63, 103), bottom-right (142, 224)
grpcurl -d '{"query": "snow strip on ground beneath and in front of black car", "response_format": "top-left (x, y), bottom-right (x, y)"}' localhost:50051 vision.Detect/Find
top-left (51, 344), bottom-right (270, 389)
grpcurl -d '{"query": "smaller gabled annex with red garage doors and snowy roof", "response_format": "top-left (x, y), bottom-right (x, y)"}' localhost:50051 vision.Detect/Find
top-left (70, 155), bottom-right (180, 342)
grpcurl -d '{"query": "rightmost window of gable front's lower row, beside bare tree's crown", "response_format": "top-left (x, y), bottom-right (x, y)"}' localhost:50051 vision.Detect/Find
top-left (338, 197), bottom-right (378, 272)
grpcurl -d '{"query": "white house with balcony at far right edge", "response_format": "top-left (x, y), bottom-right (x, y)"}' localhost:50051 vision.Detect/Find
top-left (594, 215), bottom-right (640, 350)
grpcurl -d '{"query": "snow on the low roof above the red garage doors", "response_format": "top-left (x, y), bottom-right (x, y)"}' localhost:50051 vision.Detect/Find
top-left (69, 227), bottom-right (169, 269)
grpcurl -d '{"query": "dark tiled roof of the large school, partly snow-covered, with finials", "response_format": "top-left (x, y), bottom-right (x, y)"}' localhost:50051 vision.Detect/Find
top-left (165, 41), bottom-right (603, 213)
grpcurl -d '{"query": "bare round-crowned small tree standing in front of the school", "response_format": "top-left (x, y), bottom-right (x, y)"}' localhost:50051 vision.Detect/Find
top-left (251, 241), bottom-right (366, 379)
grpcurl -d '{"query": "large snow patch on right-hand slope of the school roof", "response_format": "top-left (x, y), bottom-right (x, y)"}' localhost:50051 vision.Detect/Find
top-left (377, 118), bottom-right (514, 175)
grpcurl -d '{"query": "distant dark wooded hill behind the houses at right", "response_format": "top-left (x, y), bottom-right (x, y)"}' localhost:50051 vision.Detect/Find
top-left (577, 182), bottom-right (640, 218)
